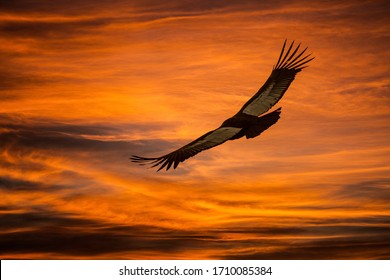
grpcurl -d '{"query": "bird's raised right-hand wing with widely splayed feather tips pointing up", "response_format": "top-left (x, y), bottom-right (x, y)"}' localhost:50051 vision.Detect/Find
top-left (240, 40), bottom-right (314, 116)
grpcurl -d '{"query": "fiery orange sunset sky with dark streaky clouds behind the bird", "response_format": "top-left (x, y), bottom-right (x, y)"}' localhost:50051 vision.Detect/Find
top-left (0, 0), bottom-right (390, 259)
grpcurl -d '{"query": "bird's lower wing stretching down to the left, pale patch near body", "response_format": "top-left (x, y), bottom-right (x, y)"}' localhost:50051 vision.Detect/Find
top-left (130, 127), bottom-right (241, 171)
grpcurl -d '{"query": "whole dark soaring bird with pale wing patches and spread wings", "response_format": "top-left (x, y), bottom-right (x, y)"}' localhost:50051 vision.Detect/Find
top-left (130, 40), bottom-right (314, 171)
